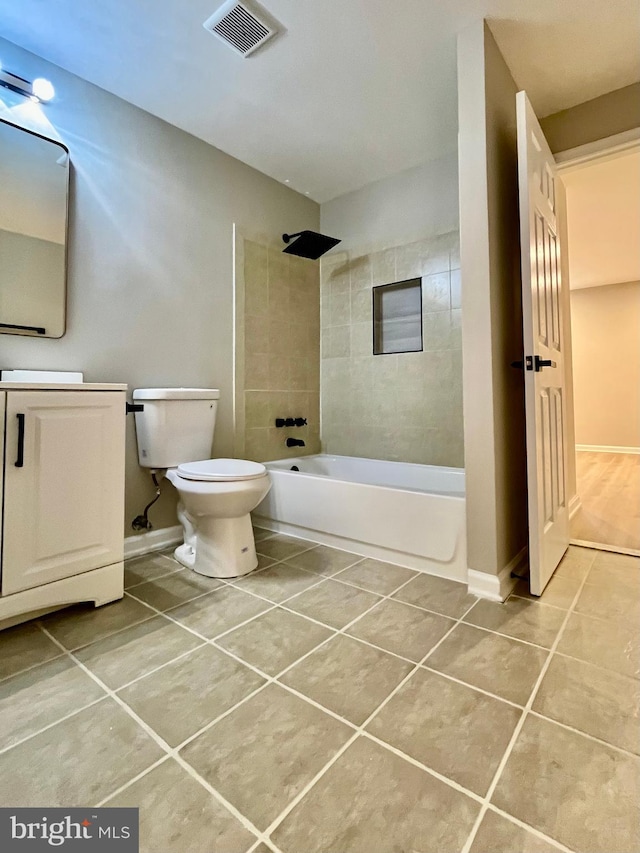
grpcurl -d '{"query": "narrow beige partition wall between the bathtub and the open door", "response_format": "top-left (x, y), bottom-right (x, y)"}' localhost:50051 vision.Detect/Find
top-left (458, 22), bottom-right (527, 574)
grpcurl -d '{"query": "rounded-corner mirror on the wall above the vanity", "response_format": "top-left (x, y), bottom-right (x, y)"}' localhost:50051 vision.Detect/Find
top-left (0, 119), bottom-right (69, 338)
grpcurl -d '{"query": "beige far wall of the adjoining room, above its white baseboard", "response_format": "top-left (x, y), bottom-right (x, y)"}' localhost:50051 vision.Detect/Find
top-left (571, 281), bottom-right (640, 449)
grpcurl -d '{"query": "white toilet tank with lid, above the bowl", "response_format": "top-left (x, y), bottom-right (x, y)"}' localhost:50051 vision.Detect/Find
top-left (133, 388), bottom-right (220, 468)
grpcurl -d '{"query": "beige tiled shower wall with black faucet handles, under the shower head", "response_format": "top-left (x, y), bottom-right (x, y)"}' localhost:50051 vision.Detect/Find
top-left (236, 239), bottom-right (320, 462)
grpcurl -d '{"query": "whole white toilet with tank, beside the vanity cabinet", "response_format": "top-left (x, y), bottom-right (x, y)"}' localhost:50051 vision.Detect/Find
top-left (133, 388), bottom-right (271, 578)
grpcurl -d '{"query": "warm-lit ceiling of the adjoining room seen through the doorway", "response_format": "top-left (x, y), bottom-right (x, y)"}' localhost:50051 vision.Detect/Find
top-left (562, 150), bottom-right (640, 290)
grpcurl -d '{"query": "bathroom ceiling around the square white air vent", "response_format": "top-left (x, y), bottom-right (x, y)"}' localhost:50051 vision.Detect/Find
top-left (0, 0), bottom-right (640, 202)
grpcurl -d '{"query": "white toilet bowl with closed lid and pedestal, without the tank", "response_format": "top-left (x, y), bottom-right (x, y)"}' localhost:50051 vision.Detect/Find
top-left (165, 459), bottom-right (271, 578)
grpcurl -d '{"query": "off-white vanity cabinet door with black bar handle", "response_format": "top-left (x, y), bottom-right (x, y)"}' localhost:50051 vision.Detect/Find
top-left (2, 391), bottom-right (125, 595)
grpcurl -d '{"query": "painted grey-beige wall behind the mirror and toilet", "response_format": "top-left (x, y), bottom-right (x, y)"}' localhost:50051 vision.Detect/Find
top-left (0, 40), bottom-right (320, 535)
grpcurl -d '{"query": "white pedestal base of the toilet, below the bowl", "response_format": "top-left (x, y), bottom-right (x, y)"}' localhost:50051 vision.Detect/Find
top-left (174, 514), bottom-right (258, 578)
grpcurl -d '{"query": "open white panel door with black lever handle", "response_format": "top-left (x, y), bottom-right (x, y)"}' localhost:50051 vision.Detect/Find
top-left (516, 92), bottom-right (569, 595)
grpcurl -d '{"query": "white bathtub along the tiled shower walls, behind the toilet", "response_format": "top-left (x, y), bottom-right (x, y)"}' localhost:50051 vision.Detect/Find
top-left (253, 454), bottom-right (467, 583)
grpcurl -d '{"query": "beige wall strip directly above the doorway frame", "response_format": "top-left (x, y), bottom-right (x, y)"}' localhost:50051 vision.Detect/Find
top-left (540, 83), bottom-right (640, 153)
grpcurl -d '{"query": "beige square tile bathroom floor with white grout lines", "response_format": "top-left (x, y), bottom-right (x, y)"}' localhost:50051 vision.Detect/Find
top-left (0, 531), bottom-right (640, 853)
